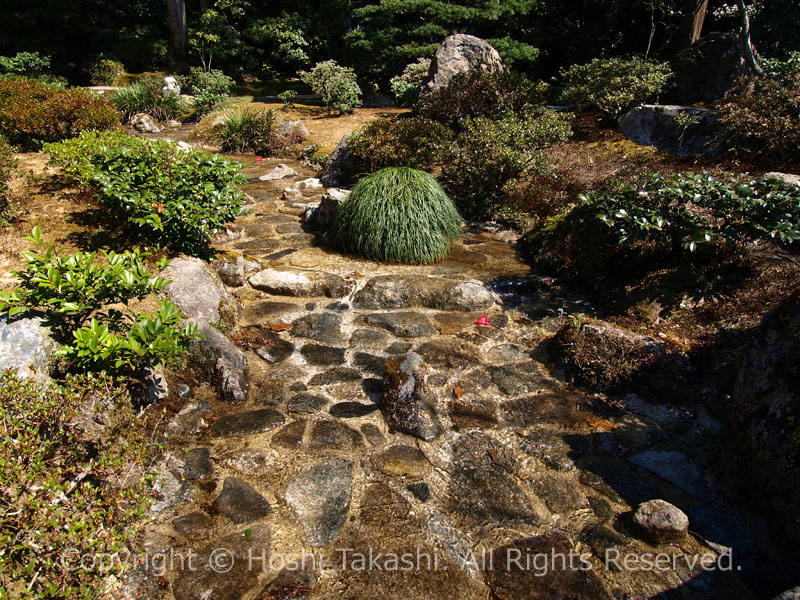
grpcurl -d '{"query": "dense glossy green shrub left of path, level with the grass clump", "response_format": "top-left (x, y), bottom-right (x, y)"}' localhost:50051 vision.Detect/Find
top-left (46, 134), bottom-right (245, 254)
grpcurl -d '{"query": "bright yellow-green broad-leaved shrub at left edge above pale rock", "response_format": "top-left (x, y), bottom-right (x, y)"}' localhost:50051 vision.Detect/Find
top-left (0, 227), bottom-right (200, 372)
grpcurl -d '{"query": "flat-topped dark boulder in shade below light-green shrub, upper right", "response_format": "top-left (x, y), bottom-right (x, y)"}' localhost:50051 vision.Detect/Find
top-left (619, 104), bottom-right (723, 156)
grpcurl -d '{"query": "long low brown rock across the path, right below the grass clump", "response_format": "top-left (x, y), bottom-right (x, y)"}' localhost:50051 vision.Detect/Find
top-left (353, 275), bottom-right (495, 311)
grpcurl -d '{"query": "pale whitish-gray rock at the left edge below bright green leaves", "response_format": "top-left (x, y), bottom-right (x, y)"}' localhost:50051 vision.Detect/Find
top-left (0, 314), bottom-right (58, 383)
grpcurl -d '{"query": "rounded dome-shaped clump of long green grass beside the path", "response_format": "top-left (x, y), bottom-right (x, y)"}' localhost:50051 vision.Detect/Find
top-left (325, 167), bottom-right (462, 264)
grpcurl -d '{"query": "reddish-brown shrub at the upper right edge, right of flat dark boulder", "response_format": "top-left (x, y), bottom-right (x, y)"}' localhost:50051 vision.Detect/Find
top-left (719, 75), bottom-right (800, 165)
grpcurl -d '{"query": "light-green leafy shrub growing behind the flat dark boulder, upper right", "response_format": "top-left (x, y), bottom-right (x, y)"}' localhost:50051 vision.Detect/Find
top-left (561, 58), bottom-right (672, 119)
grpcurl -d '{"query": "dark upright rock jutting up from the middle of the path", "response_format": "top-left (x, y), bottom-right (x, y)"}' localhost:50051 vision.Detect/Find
top-left (381, 352), bottom-right (442, 441)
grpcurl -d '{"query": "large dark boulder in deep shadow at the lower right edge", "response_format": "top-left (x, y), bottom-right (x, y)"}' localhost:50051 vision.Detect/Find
top-left (732, 292), bottom-right (800, 537)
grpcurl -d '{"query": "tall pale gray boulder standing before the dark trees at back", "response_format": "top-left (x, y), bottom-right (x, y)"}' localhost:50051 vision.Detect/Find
top-left (425, 33), bottom-right (505, 92)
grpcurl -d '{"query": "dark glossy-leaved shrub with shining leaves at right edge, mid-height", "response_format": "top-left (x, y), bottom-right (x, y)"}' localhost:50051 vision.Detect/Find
top-left (582, 173), bottom-right (800, 251)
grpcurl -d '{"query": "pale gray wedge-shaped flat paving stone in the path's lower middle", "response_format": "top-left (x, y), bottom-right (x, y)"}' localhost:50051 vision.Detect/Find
top-left (284, 458), bottom-right (353, 547)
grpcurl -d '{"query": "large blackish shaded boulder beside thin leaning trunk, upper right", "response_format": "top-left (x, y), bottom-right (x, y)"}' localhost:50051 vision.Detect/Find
top-left (664, 33), bottom-right (752, 104)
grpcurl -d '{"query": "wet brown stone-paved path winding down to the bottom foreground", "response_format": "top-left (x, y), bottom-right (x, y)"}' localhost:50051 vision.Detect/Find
top-left (127, 157), bottom-right (792, 600)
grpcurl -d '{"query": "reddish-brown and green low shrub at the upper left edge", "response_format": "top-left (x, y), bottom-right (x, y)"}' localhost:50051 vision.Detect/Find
top-left (0, 80), bottom-right (119, 150)
